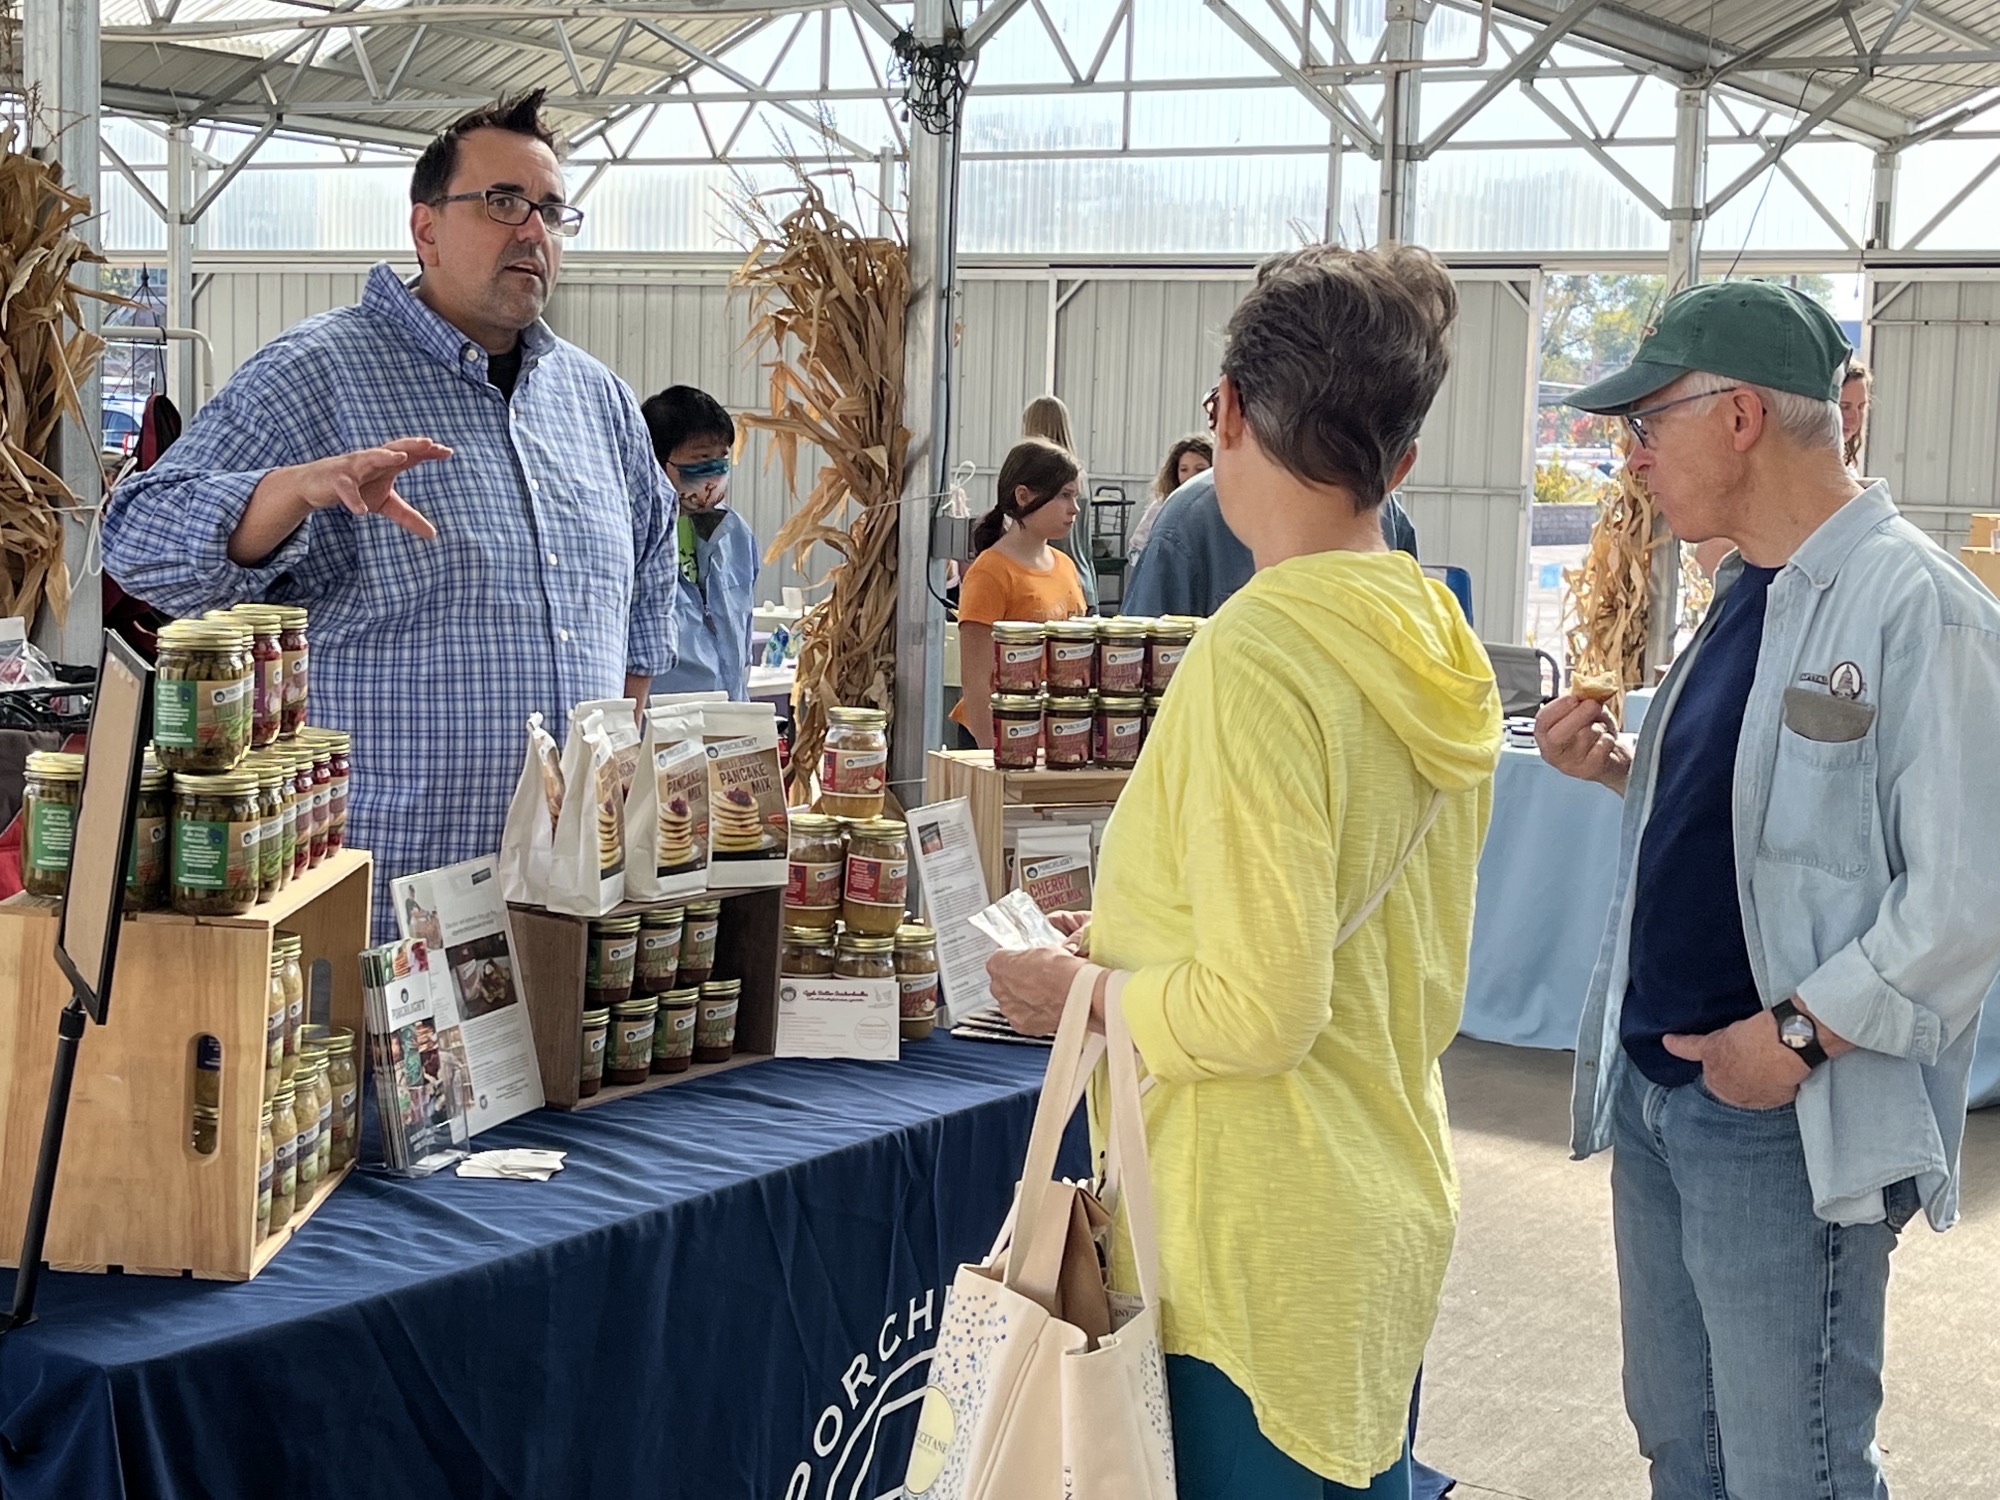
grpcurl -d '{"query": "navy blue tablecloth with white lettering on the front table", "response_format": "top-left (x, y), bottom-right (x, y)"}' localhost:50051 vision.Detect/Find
top-left (0, 1036), bottom-right (1082, 1500)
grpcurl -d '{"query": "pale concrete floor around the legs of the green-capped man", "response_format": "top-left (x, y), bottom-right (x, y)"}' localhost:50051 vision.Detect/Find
top-left (1418, 1040), bottom-right (2000, 1500)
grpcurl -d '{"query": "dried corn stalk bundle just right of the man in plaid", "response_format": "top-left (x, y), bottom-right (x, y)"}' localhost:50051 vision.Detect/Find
top-left (732, 174), bottom-right (910, 800)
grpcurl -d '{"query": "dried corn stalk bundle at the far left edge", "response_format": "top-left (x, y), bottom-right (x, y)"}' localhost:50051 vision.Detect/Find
top-left (0, 124), bottom-right (122, 622)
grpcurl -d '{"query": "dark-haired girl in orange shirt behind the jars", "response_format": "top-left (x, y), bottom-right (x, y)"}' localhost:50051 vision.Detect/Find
top-left (952, 438), bottom-right (1088, 750)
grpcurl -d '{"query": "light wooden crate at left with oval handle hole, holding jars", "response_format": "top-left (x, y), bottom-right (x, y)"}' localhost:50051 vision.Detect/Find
top-left (0, 850), bottom-right (372, 1282)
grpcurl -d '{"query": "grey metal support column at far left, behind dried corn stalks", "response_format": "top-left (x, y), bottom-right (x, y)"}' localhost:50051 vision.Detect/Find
top-left (22, 0), bottom-right (104, 666)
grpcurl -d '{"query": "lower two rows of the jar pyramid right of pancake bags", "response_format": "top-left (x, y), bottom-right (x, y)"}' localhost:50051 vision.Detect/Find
top-left (778, 812), bottom-right (938, 1042)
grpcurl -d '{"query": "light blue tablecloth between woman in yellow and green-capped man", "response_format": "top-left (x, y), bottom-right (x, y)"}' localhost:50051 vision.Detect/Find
top-left (1460, 746), bottom-right (2000, 1108)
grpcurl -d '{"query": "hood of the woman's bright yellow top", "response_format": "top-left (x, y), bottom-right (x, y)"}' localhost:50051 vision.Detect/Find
top-left (1242, 552), bottom-right (1500, 792)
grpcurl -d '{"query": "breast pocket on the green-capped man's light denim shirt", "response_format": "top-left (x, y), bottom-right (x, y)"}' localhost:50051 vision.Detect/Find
top-left (1762, 688), bottom-right (1876, 880)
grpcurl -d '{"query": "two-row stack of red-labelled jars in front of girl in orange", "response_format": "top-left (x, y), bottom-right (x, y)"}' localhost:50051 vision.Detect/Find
top-left (976, 616), bottom-right (1200, 770)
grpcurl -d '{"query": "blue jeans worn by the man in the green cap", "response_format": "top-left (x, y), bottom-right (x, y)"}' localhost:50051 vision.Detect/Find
top-left (1612, 1068), bottom-right (1914, 1500)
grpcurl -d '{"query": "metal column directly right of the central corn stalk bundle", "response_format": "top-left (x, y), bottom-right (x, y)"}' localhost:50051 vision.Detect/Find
top-left (890, 0), bottom-right (958, 806)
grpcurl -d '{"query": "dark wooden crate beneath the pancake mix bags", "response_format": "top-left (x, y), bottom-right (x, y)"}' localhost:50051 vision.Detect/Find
top-left (508, 888), bottom-right (784, 1110)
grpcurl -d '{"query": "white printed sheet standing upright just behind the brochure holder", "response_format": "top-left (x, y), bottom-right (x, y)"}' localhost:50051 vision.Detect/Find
top-left (390, 854), bottom-right (544, 1134)
